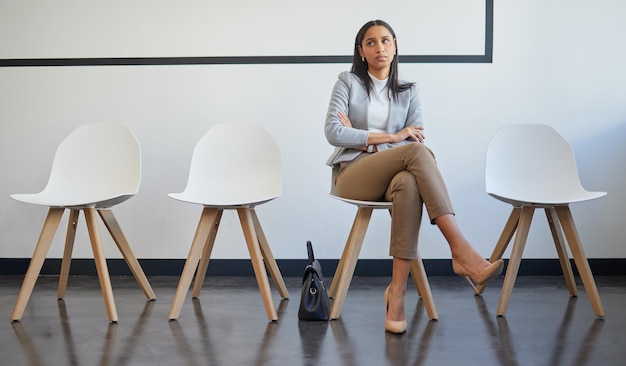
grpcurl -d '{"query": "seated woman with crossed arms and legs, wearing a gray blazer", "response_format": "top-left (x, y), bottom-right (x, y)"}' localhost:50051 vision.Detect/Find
top-left (325, 20), bottom-right (503, 333)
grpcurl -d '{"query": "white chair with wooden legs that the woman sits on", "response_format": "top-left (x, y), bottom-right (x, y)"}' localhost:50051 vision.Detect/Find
top-left (328, 167), bottom-right (439, 320)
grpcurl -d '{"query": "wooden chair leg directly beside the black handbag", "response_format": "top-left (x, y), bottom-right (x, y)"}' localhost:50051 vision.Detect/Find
top-left (330, 207), bottom-right (373, 320)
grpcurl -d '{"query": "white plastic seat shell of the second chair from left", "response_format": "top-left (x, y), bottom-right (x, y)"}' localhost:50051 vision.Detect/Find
top-left (176, 123), bottom-right (282, 206)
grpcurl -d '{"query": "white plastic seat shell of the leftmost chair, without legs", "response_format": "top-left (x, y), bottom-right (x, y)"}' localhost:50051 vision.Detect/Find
top-left (12, 123), bottom-right (141, 207)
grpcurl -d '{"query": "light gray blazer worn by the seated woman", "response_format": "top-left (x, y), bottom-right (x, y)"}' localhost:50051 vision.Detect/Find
top-left (324, 71), bottom-right (423, 166)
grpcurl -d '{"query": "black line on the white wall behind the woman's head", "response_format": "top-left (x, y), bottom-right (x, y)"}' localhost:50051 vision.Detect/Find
top-left (0, 0), bottom-right (493, 67)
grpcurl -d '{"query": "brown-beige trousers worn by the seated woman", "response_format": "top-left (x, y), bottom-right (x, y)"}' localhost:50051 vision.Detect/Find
top-left (335, 143), bottom-right (454, 259)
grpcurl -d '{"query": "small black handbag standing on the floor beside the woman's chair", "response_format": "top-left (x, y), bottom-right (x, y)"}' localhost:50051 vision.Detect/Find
top-left (298, 241), bottom-right (330, 320)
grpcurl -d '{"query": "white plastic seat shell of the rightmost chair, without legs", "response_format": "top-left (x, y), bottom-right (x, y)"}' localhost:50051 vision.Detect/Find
top-left (485, 124), bottom-right (605, 204)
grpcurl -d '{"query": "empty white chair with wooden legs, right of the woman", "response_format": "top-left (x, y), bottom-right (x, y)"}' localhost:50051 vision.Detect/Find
top-left (479, 124), bottom-right (606, 317)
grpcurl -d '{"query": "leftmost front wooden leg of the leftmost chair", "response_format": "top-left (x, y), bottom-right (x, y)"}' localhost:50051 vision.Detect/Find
top-left (11, 207), bottom-right (65, 321)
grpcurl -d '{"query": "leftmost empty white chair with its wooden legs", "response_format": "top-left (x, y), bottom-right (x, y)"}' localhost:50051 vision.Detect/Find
top-left (11, 123), bottom-right (156, 322)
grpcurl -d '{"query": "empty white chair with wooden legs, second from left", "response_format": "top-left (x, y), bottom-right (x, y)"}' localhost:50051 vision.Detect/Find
top-left (169, 123), bottom-right (289, 320)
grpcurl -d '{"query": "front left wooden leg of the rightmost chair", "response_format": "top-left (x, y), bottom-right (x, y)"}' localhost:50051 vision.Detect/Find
top-left (496, 206), bottom-right (535, 316)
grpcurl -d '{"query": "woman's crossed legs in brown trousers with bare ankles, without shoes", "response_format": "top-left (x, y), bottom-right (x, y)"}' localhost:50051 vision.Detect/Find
top-left (336, 143), bottom-right (500, 321)
